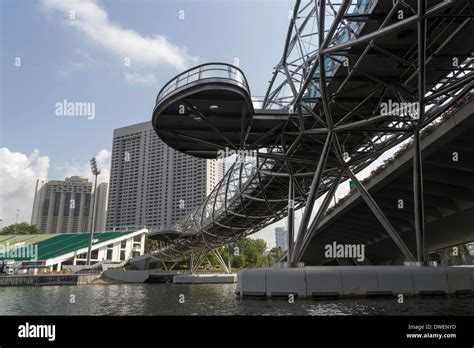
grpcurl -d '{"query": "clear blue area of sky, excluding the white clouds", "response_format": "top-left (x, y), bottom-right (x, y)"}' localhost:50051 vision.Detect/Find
top-left (1, 0), bottom-right (293, 171)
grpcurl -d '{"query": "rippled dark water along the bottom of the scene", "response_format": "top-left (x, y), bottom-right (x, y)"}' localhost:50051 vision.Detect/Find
top-left (0, 284), bottom-right (474, 315)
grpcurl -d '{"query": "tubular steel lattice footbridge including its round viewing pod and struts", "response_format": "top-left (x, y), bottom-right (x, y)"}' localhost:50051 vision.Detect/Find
top-left (149, 0), bottom-right (474, 262)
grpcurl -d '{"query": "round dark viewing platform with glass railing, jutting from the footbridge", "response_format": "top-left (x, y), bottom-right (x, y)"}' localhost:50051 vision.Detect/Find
top-left (152, 63), bottom-right (254, 158)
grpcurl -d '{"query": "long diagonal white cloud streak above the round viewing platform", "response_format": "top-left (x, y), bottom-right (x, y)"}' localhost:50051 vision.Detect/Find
top-left (42, 0), bottom-right (197, 71)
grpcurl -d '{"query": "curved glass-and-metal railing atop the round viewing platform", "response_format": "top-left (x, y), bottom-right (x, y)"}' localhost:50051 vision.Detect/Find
top-left (156, 63), bottom-right (250, 103)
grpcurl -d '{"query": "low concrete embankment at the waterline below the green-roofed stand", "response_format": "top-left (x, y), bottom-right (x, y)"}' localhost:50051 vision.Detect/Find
top-left (0, 274), bottom-right (101, 286)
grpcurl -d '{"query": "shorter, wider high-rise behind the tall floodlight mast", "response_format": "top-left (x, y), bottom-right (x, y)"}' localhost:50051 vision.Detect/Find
top-left (31, 176), bottom-right (107, 233)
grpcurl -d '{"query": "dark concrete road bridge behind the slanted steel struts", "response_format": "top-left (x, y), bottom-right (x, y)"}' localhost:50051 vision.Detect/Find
top-left (301, 92), bottom-right (474, 265)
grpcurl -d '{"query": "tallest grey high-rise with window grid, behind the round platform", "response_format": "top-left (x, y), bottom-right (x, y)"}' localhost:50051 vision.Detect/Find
top-left (107, 122), bottom-right (224, 230)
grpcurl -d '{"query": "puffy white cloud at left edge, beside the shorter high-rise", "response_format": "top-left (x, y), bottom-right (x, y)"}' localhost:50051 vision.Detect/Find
top-left (0, 147), bottom-right (49, 227)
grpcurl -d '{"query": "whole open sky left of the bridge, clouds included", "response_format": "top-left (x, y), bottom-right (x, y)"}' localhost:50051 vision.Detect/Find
top-left (0, 0), bottom-right (294, 245)
